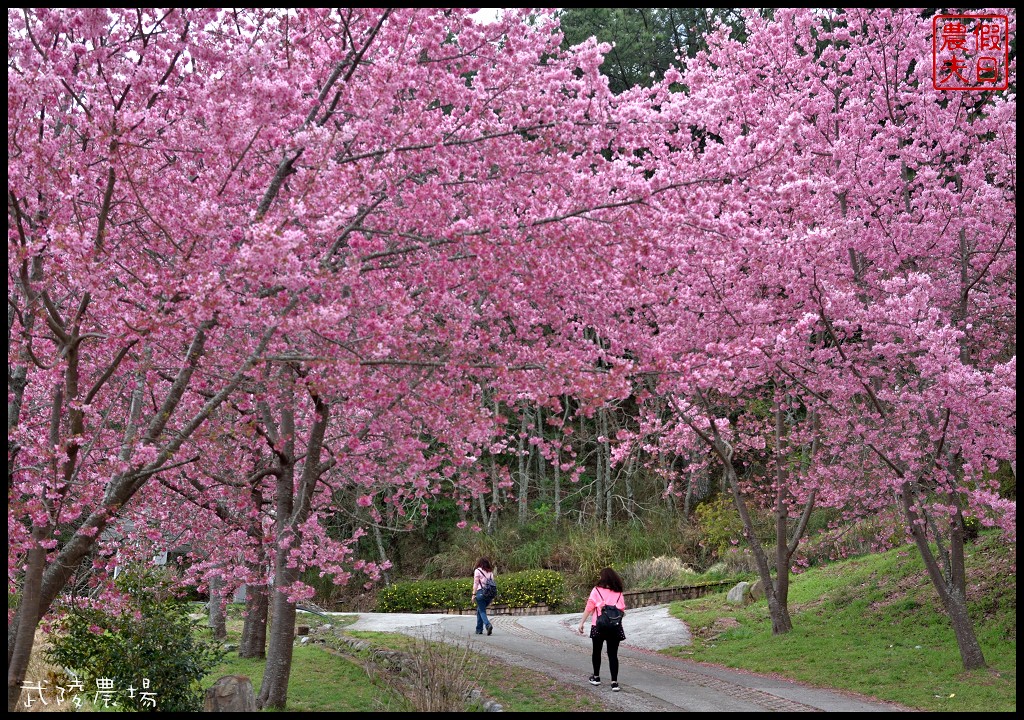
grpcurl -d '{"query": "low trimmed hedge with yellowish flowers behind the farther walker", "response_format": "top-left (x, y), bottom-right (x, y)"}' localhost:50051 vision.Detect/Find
top-left (377, 570), bottom-right (565, 612)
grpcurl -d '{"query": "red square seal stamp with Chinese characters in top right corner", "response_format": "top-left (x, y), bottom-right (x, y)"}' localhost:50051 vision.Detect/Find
top-left (932, 14), bottom-right (1010, 90)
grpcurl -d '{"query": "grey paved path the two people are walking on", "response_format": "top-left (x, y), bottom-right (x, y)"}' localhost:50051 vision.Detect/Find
top-left (346, 605), bottom-right (907, 713)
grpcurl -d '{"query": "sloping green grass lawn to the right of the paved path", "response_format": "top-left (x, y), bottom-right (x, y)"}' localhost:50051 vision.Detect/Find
top-left (670, 536), bottom-right (1017, 712)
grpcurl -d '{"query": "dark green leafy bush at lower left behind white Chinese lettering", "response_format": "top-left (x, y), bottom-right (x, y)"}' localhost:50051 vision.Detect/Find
top-left (46, 571), bottom-right (224, 713)
